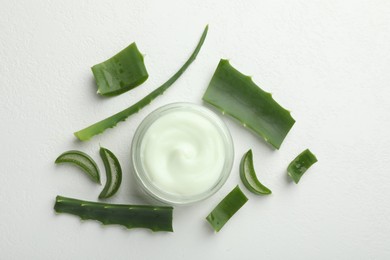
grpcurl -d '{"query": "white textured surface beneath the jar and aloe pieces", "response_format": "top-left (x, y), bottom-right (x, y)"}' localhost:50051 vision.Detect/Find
top-left (0, 0), bottom-right (390, 259)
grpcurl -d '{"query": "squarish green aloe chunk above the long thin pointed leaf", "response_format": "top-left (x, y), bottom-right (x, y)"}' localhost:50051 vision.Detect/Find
top-left (91, 42), bottom-right (149, 96)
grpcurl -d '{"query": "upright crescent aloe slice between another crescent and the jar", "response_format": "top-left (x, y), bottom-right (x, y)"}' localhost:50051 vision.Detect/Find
top-left (99, 147), bottom-right (122, 199)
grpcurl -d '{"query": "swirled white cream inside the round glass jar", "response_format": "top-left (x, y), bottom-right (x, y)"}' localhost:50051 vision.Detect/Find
top-left (140, 110), bottom-right (226, 196)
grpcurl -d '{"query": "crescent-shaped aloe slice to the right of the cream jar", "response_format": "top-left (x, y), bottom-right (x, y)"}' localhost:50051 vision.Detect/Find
top-left (240, 150), bottom-right (272, 195)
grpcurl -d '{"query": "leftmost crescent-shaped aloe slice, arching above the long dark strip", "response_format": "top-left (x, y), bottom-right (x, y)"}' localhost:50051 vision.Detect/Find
top-left (55, 150), bottom-right (100, 184)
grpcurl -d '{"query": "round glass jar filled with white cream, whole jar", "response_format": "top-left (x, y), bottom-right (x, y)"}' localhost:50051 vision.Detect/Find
top-left (131, 103), bottom-right (234, 205)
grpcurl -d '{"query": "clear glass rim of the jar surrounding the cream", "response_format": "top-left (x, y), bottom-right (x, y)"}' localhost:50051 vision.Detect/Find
top-left (131, 102), bottom-right (234, 205)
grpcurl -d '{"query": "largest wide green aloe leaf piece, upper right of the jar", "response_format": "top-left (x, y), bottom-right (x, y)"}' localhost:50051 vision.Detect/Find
top-left (203, 60), bottom-right (295, 149)
